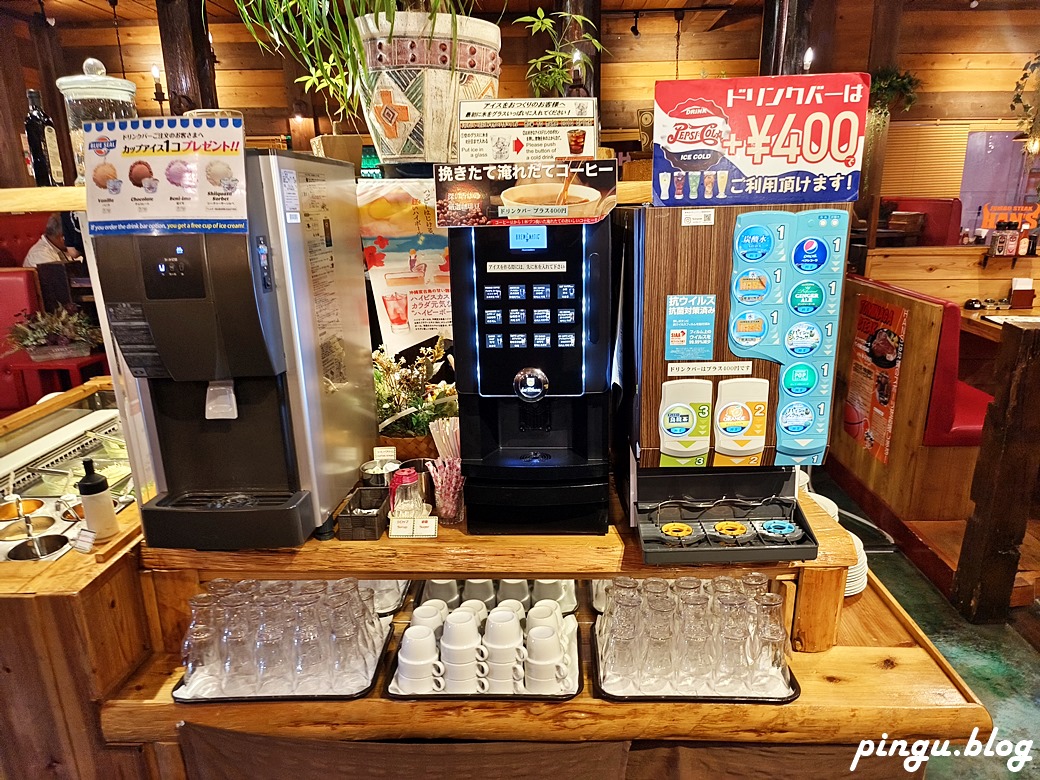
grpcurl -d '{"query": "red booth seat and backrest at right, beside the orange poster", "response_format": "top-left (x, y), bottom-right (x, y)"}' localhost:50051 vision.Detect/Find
top-left (856, 280), bottom-right (993, 447)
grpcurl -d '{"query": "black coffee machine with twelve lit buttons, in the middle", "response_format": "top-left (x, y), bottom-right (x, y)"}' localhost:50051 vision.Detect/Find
top-left (450, 219), bottom-right (613, 534)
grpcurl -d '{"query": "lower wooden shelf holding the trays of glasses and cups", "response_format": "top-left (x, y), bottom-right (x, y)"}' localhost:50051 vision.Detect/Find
top-left (101, 575), bottom-right (991, 744)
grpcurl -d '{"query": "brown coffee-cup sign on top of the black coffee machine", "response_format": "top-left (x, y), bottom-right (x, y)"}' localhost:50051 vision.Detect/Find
top-left (435, 159), bottom-right (618, 228)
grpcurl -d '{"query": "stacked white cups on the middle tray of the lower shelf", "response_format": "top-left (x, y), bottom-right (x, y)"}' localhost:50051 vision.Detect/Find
top-left (395, 580), bottom-right (571, 695)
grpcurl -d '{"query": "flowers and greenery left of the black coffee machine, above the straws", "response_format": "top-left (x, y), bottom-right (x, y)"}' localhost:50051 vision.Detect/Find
top-left (372, 339), bottom-right (459, 438)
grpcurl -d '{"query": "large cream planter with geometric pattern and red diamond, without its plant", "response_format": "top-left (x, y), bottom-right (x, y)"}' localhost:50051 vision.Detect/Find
top-left (358, 11), bottom-right (502, 163)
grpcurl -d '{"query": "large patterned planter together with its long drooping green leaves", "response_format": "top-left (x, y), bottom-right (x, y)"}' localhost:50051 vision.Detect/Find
top-left (235, 0), bottom-right (501, 163)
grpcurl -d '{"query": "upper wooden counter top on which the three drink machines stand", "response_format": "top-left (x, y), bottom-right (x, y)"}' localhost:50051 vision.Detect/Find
top-left (141, 498), bottom-right (856, 579)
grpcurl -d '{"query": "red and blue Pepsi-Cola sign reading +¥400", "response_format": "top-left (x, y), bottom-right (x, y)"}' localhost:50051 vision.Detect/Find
top-left (653, 73), bottom-right (870, 206)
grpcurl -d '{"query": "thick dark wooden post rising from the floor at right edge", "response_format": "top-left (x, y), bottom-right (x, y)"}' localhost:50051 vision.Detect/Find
top-left (952, 323), bottom-right (1040, 623)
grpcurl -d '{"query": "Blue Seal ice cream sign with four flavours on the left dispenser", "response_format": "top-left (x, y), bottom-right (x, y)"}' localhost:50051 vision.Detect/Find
top-left (83, 118), bottom-right (246, 235)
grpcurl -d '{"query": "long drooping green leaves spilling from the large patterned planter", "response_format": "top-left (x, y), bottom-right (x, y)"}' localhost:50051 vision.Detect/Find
top-left (235, 0), bottom-right (473, 116)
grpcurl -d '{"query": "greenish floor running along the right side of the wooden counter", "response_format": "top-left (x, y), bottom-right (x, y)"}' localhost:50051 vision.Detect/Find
top-left (812, 469), bottom-right (1040, 780)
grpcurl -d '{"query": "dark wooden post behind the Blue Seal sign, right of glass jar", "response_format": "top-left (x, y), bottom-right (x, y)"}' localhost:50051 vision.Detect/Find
top-left (155, 0), bottom-right (217, 115)
